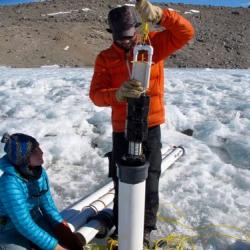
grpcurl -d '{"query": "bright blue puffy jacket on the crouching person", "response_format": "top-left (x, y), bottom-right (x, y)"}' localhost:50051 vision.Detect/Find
top-left (0, 156), bottom-right (63, 250)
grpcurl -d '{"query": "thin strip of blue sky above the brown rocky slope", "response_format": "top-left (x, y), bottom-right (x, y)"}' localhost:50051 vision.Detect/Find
top-left (0, 0), bottom-right (250, 7)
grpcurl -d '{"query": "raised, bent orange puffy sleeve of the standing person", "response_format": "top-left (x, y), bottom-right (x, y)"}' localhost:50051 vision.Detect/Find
top-left (150, 9), bottom-right (194, 62)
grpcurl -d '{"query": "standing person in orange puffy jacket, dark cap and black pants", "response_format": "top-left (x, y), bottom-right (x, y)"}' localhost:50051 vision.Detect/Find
top-left (89, 0), bottom-right (194, 246)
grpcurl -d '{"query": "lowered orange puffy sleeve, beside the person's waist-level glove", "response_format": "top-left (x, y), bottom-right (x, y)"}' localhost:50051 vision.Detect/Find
top-left (89, 54), bottom-right (118, 107)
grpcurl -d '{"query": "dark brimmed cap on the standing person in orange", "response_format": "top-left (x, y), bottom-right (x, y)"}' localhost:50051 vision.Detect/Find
top-left (107, 5), bottom-right (140, 41)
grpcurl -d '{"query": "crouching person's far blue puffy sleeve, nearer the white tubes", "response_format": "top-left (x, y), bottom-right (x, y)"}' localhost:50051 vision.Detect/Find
top-left (40, 170), bottom-right (63, 226)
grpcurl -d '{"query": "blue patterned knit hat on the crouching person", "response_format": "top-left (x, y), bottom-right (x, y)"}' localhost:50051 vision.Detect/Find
top-left (1, 133), bottom-right (39, 166)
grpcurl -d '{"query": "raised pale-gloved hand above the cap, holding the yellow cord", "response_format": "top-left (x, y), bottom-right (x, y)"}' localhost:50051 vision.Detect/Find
top-left (136, 0), bottom-right (163, 23)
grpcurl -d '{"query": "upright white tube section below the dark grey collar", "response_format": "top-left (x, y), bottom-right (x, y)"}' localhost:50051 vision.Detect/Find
top-left (118, 181), bottom-right (145, 250)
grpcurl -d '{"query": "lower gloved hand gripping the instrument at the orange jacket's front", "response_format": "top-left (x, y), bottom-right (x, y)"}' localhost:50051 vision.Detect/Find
top-left (115, 80), bottom-right (144, 102)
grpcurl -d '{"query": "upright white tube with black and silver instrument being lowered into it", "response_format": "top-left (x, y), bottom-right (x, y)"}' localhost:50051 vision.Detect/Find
top-left (118, 45), bottom-right (153, 250)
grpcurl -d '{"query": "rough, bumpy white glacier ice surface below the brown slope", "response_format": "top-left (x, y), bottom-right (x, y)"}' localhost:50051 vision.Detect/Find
top-left (0, 67), bottom-right (250, 250)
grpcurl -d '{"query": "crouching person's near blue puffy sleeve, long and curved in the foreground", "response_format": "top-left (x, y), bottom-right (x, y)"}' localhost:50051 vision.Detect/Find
top-left (0, 176), bottom-right (58, 250)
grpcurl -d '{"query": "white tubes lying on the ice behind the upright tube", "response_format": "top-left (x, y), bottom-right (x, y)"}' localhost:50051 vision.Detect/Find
top-left (61, 146), bottom-right (185, 245)
